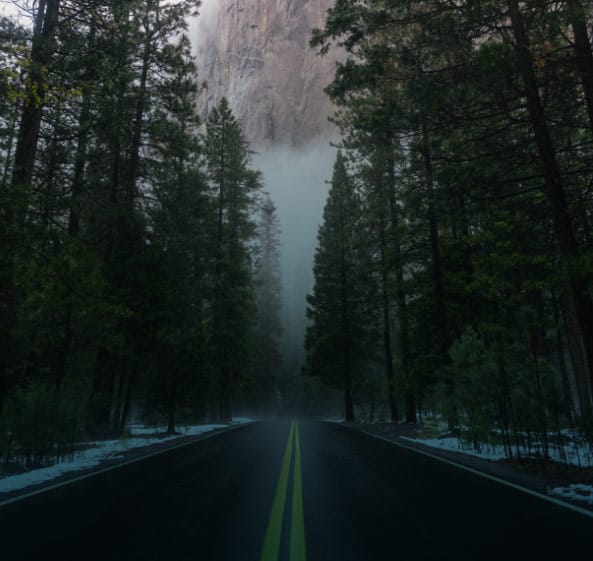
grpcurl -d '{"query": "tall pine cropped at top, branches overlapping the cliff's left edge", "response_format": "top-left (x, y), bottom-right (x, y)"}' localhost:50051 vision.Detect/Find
top-left (87, 1), bottom-right (204, 432)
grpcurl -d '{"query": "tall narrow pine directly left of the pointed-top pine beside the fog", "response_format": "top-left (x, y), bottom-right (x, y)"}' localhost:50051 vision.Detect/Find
top-left (142, 30), bottom-right (212, 433)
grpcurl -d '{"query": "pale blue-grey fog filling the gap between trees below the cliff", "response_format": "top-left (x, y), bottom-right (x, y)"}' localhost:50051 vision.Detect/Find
top-left (252, 139), bottom-right (335, 374)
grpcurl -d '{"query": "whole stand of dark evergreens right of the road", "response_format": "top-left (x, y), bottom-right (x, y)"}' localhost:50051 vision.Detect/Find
top-left (306, 0), bottom-right (593, 458)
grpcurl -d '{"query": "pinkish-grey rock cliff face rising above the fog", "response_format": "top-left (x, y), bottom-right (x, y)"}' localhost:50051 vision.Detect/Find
top-left (195, 0), bottom-right (336, 147)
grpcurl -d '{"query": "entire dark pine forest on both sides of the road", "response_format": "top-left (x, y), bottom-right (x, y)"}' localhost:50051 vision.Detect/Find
top-left (0, 0), bottom-right (593, 473)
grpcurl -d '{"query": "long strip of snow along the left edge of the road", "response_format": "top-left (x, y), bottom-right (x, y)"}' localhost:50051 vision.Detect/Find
top-left (0, 417), bottom-right (251, 493)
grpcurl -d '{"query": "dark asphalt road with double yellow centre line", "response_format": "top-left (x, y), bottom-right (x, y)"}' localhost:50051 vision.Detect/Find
top-left (0, 421), bottom-right (593, 561)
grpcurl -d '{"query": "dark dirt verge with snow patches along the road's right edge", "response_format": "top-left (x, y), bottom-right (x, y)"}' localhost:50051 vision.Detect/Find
top-left (350, 423), bottom-right (593, 511)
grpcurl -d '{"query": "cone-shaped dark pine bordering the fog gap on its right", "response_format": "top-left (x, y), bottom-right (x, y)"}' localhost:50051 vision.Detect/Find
top-left (305, 152), bottom-right (373, 421)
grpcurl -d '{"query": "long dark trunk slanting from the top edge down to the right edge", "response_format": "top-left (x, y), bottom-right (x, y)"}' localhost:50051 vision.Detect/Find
top-left (508, 0), bottom-right (593, 412)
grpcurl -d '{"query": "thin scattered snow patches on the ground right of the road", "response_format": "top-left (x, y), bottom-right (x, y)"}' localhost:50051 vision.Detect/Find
top-left (401, 436), bottom-right (593, 505)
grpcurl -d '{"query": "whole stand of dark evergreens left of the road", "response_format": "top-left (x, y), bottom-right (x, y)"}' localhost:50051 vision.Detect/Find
top-left (0, 0), bottom-right (281, 469)
